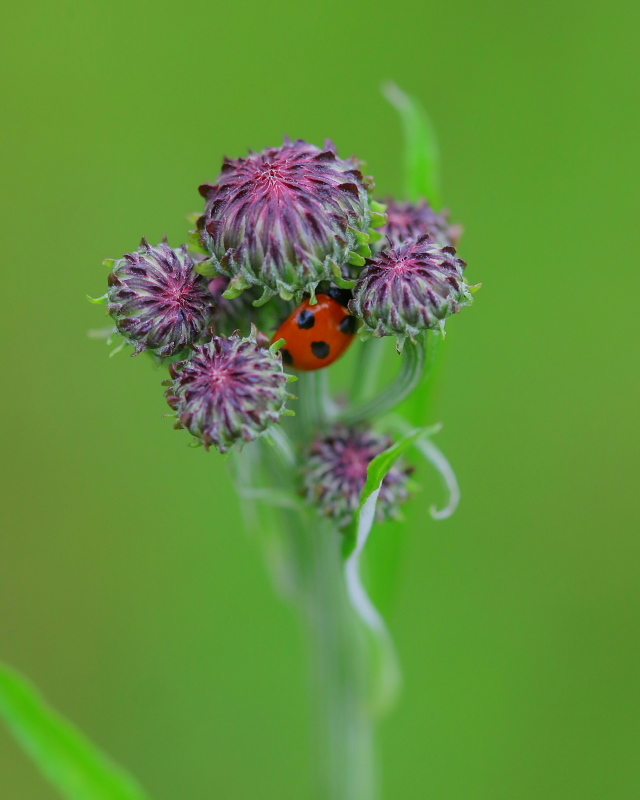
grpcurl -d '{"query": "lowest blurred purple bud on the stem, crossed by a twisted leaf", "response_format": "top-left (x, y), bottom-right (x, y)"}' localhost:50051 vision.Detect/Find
top-left (304, 425), bottom-right (413, 528)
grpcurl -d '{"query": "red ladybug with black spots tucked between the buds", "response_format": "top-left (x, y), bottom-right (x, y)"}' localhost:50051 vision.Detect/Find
top-left (272, 287), bottom-right (358, 372)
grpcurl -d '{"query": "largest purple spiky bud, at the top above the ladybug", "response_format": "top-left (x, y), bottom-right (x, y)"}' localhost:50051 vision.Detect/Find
top-left (198, 139), bottom-right (386, 302)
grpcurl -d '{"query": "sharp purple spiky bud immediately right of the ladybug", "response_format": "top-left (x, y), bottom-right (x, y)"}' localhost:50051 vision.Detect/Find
top-left (349, 231), bottom-right (471, 349)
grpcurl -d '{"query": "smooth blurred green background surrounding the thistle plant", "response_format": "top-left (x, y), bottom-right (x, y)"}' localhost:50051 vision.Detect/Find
top-left (0, 0), bottom-right (640, 800)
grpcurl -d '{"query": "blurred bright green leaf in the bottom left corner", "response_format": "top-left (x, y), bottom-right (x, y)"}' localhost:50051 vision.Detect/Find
top-left (0, 663), bottom-right (148, 800)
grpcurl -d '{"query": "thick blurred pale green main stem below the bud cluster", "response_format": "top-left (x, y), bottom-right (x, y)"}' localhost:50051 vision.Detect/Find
top-left (246, 373), bottom-right (377, 800)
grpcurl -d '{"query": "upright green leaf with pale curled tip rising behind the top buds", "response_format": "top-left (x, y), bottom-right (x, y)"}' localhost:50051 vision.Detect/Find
top-left (382, 83), bottom-right (442, 209)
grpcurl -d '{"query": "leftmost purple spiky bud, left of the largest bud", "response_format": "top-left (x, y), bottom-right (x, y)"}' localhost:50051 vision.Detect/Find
top-left (106, 239), bottom-right (214, 357)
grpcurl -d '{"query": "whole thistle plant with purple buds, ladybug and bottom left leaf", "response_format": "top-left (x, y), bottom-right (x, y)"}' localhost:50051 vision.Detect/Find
top-left (0, 87), bottom-right (474, 800)
